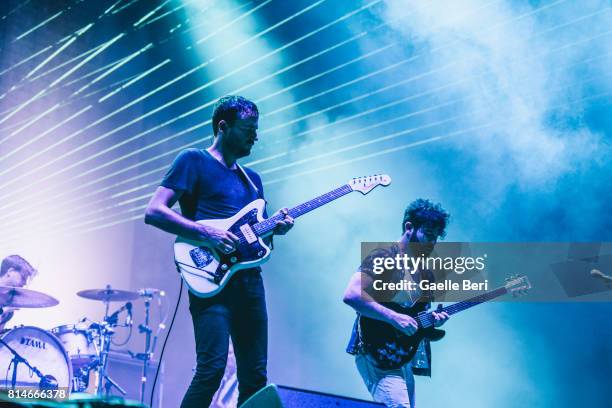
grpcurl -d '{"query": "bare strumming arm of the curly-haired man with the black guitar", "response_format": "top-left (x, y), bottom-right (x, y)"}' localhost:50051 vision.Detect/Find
top-left (343, 272), bottom-right (417, 334)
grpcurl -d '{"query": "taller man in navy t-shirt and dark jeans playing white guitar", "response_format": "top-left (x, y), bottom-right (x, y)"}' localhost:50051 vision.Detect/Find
top-left (145, 96), bottom-right (293, 408)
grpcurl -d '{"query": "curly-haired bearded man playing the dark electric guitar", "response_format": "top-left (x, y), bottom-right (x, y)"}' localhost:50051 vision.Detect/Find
top-left (344, 199), bottom-right (449, 408)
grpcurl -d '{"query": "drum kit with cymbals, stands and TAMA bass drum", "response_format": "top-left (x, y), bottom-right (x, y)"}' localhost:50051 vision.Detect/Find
top-left (0, 285), bottom-right (164, 402)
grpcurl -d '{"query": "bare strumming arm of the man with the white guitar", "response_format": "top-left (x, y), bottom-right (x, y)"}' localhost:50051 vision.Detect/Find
top-left (145, 186), bottom-right (238, 253)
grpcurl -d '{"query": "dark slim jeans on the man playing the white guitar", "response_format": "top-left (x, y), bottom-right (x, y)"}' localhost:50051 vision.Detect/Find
top-left (181, 269), bottom-right (268, 408)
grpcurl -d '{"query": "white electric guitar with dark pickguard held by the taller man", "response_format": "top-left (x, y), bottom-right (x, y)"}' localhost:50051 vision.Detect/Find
top-left (174, 174), bottom-right (391, 297)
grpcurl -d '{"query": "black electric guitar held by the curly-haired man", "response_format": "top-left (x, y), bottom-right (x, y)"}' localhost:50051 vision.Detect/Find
top-left (359, 276), bottom-right (531, 369)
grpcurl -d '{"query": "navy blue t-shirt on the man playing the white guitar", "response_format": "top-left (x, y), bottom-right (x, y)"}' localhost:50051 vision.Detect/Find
top-left (161, 149), bottom-right (266, 221)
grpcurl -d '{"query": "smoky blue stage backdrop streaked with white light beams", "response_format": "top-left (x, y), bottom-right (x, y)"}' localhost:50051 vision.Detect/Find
top-left (0, 0), bottom-right (612, 407)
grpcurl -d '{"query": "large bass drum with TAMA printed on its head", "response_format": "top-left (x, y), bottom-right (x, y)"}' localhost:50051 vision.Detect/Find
top-left (0, 326), bottom-right (72, 392)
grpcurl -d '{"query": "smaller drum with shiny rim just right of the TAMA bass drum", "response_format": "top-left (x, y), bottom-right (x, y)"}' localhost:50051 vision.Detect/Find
top-left (51, 323), bottom-right (100, 371)
